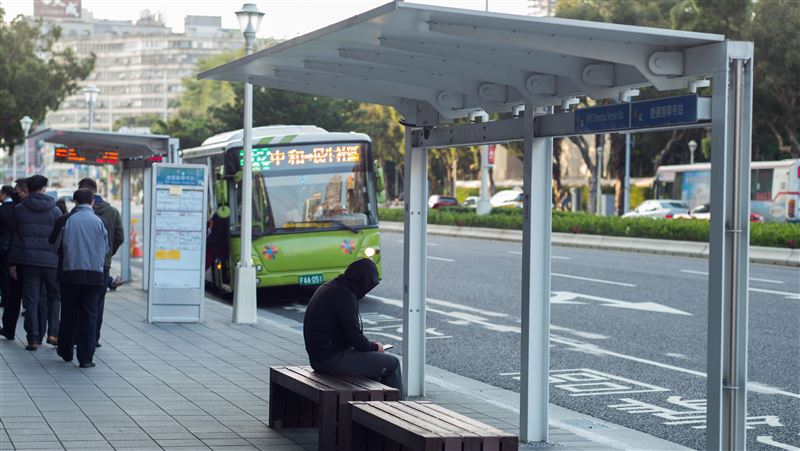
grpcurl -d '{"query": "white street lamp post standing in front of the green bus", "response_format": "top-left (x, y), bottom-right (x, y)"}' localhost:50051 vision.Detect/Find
top-left (233, 3), bottom-right (264, 324)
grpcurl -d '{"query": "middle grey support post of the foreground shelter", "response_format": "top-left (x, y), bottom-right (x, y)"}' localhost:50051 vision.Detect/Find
top-left (519, 102), bottom-right (553, 442)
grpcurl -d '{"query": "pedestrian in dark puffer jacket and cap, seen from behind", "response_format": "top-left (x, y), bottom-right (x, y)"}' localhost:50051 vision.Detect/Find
top-left (8, 174), bottom-right (61, 351)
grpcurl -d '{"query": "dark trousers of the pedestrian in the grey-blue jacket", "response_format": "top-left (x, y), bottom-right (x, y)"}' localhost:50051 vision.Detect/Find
top-left (58, 283), bottom-right (105, 364)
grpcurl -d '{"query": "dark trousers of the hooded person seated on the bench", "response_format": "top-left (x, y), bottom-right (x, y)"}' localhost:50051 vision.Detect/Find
top-left (311, 348), bottom-right (405, 399)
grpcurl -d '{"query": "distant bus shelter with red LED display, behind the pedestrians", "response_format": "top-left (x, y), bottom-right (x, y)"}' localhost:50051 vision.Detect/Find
top-left (29, 128), bottom-right (179, 289)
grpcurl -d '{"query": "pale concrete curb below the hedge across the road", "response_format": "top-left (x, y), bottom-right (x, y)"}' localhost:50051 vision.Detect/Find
top-left (380, 221), bottom-right (800, 267)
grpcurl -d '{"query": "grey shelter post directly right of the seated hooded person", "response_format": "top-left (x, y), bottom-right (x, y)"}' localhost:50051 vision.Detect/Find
top-left (403, 127), bottom-right (428, 396)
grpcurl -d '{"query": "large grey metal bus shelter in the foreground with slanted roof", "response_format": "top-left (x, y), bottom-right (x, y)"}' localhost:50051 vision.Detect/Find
top-left (199, 0), bottom-right (753, 450)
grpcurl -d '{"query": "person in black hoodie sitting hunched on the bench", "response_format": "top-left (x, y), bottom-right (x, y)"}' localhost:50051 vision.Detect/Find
top-left (303, 258), bottom-right (404, 399)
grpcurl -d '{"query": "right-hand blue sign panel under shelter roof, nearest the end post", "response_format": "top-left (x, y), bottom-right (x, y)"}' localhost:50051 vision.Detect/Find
top-left (631, 94), bottom-right (697, 128)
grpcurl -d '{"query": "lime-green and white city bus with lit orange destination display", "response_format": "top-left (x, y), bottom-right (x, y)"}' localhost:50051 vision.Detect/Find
top-left (182, 125), bottom-right (385, 291)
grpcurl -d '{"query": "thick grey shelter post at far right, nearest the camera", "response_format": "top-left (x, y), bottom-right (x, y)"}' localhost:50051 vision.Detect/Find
top-left (706, 42), bottom-right (753, 450)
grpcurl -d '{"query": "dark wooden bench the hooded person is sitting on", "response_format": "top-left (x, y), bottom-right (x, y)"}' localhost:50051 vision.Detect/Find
top-left (269, 366), bottom-right (400, 450)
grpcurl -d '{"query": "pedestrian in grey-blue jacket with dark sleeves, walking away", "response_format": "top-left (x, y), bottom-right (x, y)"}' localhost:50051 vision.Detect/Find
top-left (49, 189), bottom-right (109, 368)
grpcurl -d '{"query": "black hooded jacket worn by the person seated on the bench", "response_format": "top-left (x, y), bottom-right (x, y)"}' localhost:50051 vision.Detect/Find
top-left (303, 258), bottom-right (378, 362)
